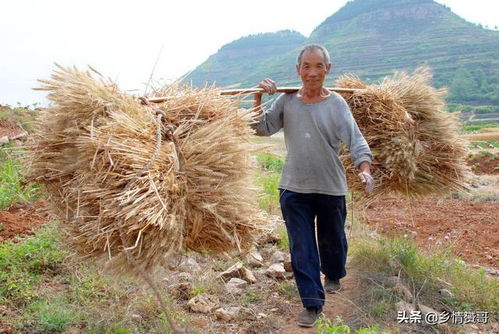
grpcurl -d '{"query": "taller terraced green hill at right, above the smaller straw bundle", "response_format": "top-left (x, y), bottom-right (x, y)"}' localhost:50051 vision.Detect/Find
top-left (309, 0), bottom-right (499, 84)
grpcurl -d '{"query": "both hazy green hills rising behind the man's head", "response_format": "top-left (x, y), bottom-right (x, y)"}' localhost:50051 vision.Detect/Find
top-left (188, 0), bottom-right (499, 112)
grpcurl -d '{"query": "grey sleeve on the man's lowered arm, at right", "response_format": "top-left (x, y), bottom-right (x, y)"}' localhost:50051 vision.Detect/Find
top-left (338, 101), bottom-right (373, 167)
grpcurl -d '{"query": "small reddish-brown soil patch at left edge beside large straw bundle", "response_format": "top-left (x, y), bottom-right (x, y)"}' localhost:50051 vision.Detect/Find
top-left (0, 200), bottom-right (50, 242)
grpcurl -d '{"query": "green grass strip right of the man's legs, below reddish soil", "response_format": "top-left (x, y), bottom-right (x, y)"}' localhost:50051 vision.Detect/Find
top-left (351, 238), bottom-right (499, 316)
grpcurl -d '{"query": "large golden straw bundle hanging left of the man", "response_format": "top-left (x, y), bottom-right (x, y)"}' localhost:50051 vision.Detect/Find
top-left (31, 67), bottom-right (262, 271)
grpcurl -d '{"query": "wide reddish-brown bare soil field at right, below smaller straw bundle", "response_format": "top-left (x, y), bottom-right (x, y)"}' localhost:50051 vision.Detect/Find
top-left (366, 197), bottom-right (499, 268)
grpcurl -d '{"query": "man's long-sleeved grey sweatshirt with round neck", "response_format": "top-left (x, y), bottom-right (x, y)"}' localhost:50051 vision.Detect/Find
top-left (253, 92), bottom-right (372, 196)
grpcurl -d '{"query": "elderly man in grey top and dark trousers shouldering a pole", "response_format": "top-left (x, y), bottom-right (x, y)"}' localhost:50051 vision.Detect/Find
top-left (253, 44), bottom-right (374, 327)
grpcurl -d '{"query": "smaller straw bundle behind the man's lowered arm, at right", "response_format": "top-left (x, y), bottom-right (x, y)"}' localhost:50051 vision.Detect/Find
top-left (337, 68), bottom-right (468, 197)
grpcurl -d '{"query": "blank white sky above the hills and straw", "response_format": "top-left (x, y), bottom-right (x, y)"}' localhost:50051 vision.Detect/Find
top-left (0, 0), bottom-right (499, 105)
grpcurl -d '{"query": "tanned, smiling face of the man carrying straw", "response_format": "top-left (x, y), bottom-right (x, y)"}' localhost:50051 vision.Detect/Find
top-left (296, 49), bottom-right (331, 89)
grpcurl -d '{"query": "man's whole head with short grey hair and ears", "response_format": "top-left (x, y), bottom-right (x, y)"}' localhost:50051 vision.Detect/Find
top-left (296, 44), bottom-right (331, 89)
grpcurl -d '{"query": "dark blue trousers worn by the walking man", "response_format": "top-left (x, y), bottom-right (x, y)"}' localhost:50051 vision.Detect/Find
top-left (279, 189), bottom-right (348, 307)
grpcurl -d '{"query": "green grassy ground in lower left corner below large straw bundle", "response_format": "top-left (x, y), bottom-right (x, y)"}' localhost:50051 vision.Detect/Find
top-left (0, 217), bottom-right (180, 333)
